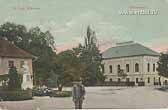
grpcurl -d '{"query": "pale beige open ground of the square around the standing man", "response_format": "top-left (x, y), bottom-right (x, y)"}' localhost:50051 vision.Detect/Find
top-left (0, 86), bottom-right (168, 110)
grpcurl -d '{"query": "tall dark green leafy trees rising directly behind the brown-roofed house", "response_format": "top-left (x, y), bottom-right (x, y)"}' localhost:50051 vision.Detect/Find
top-left (0, 22), bottom-right (55, 85)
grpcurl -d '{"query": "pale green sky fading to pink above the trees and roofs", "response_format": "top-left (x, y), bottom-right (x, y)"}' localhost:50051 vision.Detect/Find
top-left (0, 0), bottom-right (168, 52)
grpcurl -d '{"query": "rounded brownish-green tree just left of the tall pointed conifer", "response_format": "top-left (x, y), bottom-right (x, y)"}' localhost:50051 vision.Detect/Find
top-left (55, 50), bottom-right (83, 85)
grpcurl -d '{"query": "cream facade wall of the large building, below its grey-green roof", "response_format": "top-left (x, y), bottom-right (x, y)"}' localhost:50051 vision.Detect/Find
top-left (103, 56), bottom-right (163, 85)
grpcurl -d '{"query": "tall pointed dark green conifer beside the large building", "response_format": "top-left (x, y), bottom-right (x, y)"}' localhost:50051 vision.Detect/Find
top-left (79, 26), bottom-right (105, 85)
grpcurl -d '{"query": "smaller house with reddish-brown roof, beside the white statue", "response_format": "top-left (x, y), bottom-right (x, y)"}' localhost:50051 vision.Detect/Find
top-left (0, 37), bottom-right (33, 89)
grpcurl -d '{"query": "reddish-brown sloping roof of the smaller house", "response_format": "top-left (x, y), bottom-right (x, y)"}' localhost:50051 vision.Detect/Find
top-left (0, 37), bottom-right (33, 58)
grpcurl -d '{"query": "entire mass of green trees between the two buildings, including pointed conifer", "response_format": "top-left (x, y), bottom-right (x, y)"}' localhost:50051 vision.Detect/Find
top-left (0, 22), bottom-right (104, 87)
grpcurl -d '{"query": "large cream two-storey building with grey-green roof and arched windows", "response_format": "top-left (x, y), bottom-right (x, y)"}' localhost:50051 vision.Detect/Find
top-left (102, 41), bottom-right (166, 85)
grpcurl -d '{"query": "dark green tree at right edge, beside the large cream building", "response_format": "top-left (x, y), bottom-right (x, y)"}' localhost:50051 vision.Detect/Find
top-left (157, 53), bottom-right (168, 77)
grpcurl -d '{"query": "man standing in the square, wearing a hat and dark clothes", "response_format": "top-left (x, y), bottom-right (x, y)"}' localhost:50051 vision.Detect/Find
top-left (72, 81), bottom-right (85, 109)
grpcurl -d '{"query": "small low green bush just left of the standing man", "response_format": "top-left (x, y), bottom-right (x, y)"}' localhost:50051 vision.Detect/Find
top-left (50, 91), bottom-right (72, 97)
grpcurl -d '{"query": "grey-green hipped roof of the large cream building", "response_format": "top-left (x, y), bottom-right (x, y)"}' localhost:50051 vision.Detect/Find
top-left (102, 43), bottom-right (160, 59)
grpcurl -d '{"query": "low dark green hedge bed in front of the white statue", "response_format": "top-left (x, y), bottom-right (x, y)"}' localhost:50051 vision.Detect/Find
top-left (0, 89), bottom-right (32, 101)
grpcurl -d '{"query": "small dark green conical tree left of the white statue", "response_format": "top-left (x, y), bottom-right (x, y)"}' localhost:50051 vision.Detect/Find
top-left (8, 67), bottom-right (22, 89)
